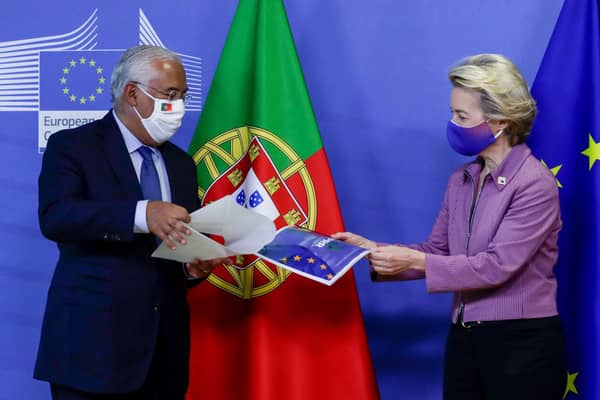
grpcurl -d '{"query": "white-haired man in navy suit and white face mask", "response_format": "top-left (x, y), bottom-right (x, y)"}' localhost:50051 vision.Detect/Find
top-left (34, 46), bottom-right (223, 400)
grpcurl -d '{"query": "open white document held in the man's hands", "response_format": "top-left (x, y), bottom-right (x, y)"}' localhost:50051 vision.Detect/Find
top-left (152, 195), bottom-right (276, 262)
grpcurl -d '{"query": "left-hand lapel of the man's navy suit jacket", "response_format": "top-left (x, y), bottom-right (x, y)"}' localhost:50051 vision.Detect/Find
top-left (100, 110), bottom-right (142, 200)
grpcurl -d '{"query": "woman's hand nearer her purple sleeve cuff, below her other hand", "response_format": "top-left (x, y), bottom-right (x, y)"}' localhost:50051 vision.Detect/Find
top-left (369, 246), bottom-right (425, 275)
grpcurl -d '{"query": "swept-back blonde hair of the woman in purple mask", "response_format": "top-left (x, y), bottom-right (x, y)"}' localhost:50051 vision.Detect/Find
top-left (448, 54), bottom-right (537, 145)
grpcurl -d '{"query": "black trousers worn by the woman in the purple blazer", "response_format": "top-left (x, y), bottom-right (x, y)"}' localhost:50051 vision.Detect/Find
top-left (444, 317), bottom-right (567, 400)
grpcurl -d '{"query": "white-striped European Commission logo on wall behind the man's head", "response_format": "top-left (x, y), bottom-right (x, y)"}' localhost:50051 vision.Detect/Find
top-left (0, 9), bottom-right (202, 153)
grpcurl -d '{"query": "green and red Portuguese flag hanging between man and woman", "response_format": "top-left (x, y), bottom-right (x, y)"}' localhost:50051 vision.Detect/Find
top-left (188, 0), bottom-right (378, 400)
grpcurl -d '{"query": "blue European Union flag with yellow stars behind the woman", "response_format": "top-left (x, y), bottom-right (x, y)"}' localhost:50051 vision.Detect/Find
top-left (530, 0), bottom-right (600, 399)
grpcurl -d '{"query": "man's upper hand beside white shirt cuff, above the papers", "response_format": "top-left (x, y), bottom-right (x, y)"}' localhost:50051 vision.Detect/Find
top-left (146, 201), bottom-right (192, 250)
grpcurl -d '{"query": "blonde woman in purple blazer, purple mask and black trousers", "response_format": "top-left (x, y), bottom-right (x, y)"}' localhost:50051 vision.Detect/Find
top-left (334, 54), bottom-right (567, 400)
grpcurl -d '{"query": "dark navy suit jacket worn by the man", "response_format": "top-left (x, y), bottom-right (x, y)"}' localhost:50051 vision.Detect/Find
top-left (34, 112), bottom-right (199, 393)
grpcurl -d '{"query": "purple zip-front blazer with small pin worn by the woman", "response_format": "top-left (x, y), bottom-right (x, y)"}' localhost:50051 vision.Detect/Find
top-left (375, 144), bottom-right (562, 322)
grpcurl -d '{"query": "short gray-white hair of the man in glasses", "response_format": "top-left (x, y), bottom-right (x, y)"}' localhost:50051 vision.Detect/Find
top-left (110, 45), bottom-right (181, 105)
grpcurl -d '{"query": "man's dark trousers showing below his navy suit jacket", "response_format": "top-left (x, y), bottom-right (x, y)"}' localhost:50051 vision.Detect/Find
top-left (50, 318), bottom-right (187, 400)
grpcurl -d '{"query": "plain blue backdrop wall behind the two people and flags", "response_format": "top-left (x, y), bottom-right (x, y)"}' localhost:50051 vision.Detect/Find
top-left (0, 0), bottom-right (562, 400)
